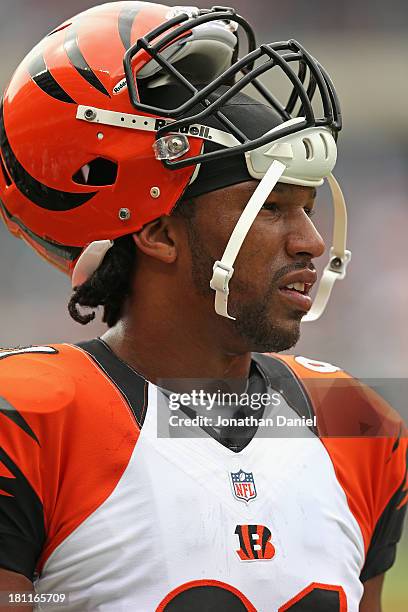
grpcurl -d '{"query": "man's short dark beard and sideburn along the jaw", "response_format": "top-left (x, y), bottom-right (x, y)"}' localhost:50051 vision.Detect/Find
top-left (188, 220), bottom-right (305, 353)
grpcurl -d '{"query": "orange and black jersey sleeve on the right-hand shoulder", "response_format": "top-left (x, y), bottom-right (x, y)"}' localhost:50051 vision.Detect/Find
top-left (274, 357), bottom-right (408, 582)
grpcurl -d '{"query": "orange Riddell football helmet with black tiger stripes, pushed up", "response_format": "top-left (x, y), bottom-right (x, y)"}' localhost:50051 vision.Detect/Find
top-left (0, 1), bottom-right (347, 316)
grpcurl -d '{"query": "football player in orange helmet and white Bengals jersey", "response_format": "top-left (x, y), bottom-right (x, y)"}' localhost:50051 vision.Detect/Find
top-left (0, 2), bottom-right (407, 612)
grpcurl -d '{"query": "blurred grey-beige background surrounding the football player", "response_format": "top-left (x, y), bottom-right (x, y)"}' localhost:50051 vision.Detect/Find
top-left (0, 0), bottom-right (408, 612)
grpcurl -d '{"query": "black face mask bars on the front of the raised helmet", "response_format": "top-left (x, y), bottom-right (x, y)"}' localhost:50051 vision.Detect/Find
top-left (124, 7), bottom-right (341, 169)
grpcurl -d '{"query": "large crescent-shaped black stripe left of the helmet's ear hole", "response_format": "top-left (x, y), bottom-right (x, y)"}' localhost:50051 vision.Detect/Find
top-left (0, 102), bottom-right (98, 212)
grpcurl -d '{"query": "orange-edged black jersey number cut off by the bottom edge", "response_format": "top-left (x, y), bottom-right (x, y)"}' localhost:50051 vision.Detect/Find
top-left (157, 580), bottom-right (347, 612)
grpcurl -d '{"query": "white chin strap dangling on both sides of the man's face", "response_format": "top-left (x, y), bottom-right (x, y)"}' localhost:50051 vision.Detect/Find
top-left (210, 165), bottom-right (351, 321)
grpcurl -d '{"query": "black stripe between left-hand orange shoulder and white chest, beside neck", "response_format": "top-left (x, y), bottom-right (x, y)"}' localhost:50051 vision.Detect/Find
top-left (75, 338), bottom-right (149, 428)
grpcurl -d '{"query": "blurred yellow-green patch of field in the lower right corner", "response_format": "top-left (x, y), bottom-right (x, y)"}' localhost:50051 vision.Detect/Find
top-left (383, 526), bottom-right (408, 612)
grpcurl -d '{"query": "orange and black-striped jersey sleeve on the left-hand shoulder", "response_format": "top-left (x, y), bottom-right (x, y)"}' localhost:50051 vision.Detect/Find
top-left (0, 344), bottom-right (139, 579)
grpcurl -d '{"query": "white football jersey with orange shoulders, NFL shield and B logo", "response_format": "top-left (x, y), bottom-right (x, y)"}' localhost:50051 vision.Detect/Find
top-left (0, 340), bottom-right (406, 612)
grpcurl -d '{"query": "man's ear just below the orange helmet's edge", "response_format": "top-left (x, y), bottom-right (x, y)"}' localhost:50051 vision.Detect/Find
top-left (133, 216), bottom-right (177, 263)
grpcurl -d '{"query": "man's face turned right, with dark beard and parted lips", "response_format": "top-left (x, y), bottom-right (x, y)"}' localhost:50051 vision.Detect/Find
top-left (183, 181), bottom-right (324, 352)
